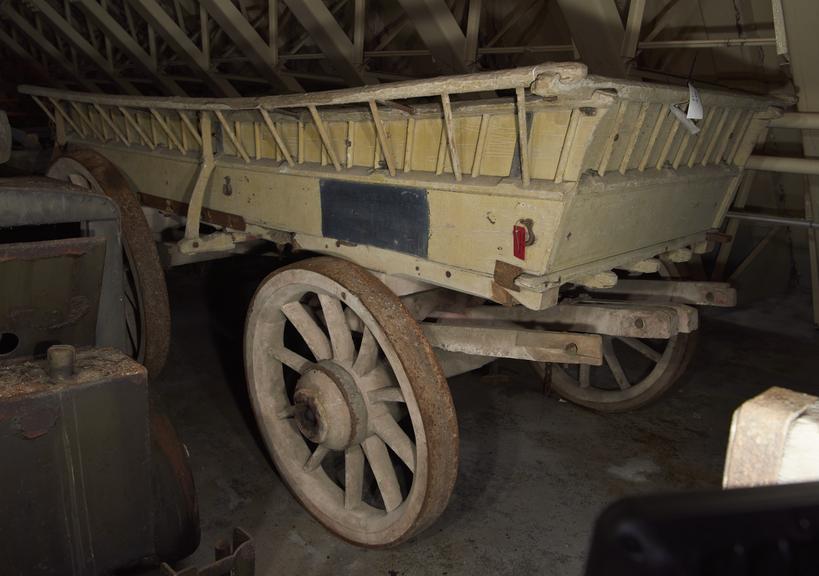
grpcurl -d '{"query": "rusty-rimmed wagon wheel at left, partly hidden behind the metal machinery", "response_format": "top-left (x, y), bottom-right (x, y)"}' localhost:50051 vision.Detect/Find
top-left (46, 150), bottom-right (171, 378)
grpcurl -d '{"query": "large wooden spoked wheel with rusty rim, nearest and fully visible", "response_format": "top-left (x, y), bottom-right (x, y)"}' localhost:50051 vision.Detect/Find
top-left (245, 258), bottom-right (458, 547)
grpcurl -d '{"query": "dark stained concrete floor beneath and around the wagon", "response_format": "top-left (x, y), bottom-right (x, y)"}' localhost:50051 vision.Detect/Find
top-left (158, 261), bottom-right (819, 576)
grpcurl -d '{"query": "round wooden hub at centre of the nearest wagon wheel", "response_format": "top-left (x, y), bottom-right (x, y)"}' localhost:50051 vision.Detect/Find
top-left (293, 361), bottom-right (367, 450)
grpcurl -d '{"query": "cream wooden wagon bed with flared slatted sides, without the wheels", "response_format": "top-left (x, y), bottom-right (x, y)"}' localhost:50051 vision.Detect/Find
top-left (21, 63), bottom-right (779, 309)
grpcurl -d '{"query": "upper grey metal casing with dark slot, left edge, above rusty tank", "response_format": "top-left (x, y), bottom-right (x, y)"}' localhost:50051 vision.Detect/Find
top-left (0, 178), bottom-right (130, 360)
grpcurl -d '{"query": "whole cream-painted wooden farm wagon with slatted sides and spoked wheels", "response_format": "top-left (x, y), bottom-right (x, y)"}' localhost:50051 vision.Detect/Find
top-left (22, 63), bottom-right (780, 546)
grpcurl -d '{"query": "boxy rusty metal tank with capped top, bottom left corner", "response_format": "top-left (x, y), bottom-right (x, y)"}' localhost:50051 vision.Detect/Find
top-left (0, 345), bottom-right (199, 576)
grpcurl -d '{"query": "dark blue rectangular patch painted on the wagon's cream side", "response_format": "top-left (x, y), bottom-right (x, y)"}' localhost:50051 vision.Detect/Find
top-left (320, 180), bottom-right (429, 257)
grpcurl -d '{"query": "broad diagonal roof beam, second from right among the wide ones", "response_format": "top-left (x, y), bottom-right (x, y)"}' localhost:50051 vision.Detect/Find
top-left (398, 0), bottom-right (467, 73)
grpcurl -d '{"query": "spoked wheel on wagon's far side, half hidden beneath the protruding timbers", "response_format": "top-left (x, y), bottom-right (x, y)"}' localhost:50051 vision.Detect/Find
top-left (533, 332), bottom-right (696, 412)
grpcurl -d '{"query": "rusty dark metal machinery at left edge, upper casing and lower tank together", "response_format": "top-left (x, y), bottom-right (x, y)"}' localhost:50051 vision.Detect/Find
top-left (0, 178), bottom-right (199, 575)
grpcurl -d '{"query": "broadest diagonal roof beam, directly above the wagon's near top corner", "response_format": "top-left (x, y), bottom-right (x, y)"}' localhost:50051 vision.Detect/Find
top-left (557, 0), bottom-right (626, 78)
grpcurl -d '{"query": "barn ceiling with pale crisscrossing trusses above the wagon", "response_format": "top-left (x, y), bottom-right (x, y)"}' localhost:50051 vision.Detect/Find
top-left (0, 0), bottom-right (789, 96)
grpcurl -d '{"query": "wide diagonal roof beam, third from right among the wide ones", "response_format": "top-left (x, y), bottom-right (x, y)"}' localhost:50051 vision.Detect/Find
top-left (284, 0), bottom-right (374, 86)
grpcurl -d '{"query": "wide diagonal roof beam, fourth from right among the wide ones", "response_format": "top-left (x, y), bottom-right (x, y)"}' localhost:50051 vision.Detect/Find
top-left (202, 0), bottom-right (303, 92)
